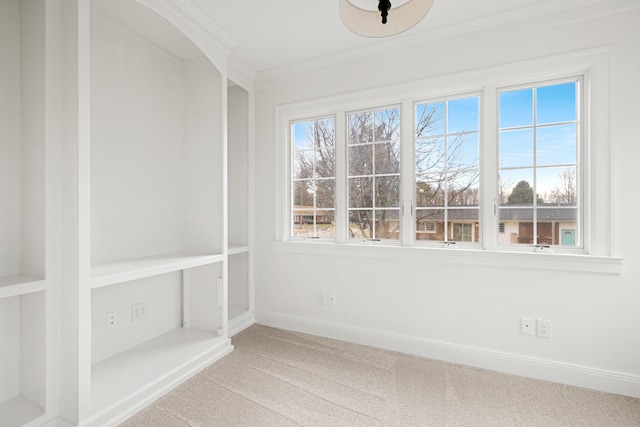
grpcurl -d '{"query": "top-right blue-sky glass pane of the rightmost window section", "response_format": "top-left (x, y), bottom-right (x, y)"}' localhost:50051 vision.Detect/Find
top-left (536, 82), bottom-right (577, 124)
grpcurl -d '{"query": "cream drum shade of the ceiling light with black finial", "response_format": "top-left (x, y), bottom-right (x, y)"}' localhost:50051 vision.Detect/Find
top-left (340, 0), bottom-right (434, 37)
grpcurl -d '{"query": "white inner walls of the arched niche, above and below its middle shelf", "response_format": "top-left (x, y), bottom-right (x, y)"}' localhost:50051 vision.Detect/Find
top-left (90, 7), bottom-right (222, 363)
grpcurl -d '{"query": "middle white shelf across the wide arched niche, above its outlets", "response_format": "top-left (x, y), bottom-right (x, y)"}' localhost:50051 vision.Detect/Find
top-left (91, 252), bottom-right (224, 289)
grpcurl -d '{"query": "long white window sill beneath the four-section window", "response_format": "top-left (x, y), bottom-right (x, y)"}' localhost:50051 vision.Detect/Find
top-left (273, 241), bottom-right (624, 275)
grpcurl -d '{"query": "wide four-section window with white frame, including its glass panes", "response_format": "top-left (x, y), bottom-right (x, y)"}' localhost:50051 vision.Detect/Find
top-left (276, 51), bottom-right (618, 264)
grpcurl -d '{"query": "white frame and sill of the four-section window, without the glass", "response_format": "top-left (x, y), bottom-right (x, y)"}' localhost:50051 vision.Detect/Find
top-left (274, 47), bottom-right (624, 274)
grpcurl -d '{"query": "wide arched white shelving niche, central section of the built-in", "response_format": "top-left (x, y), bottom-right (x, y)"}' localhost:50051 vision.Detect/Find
top-left (79, 0), bottom-right (232, 425)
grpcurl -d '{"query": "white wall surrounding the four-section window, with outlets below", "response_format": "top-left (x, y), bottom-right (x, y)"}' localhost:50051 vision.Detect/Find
top-left (254, 6), bottom-right (640, 396)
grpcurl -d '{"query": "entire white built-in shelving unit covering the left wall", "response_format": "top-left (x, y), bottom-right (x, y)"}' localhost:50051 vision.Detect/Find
top-left (0, 0), bottom-right (252, 427)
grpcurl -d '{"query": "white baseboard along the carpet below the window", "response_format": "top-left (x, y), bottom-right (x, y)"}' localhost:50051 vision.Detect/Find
top-left (255, 310), bottom-right (640, 398)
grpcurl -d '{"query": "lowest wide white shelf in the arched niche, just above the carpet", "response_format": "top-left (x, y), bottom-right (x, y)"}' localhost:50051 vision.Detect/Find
top-left (91, 328), bottom-right (233, 419)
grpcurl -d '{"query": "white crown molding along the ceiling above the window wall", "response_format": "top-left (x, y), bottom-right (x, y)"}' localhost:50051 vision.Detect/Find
top-left (255, 0), bottom-right (640, 90)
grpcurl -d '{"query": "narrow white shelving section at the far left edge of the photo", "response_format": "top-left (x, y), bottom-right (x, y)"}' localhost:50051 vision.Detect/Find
top-left (0, 0), bottom-right (50, 427)
